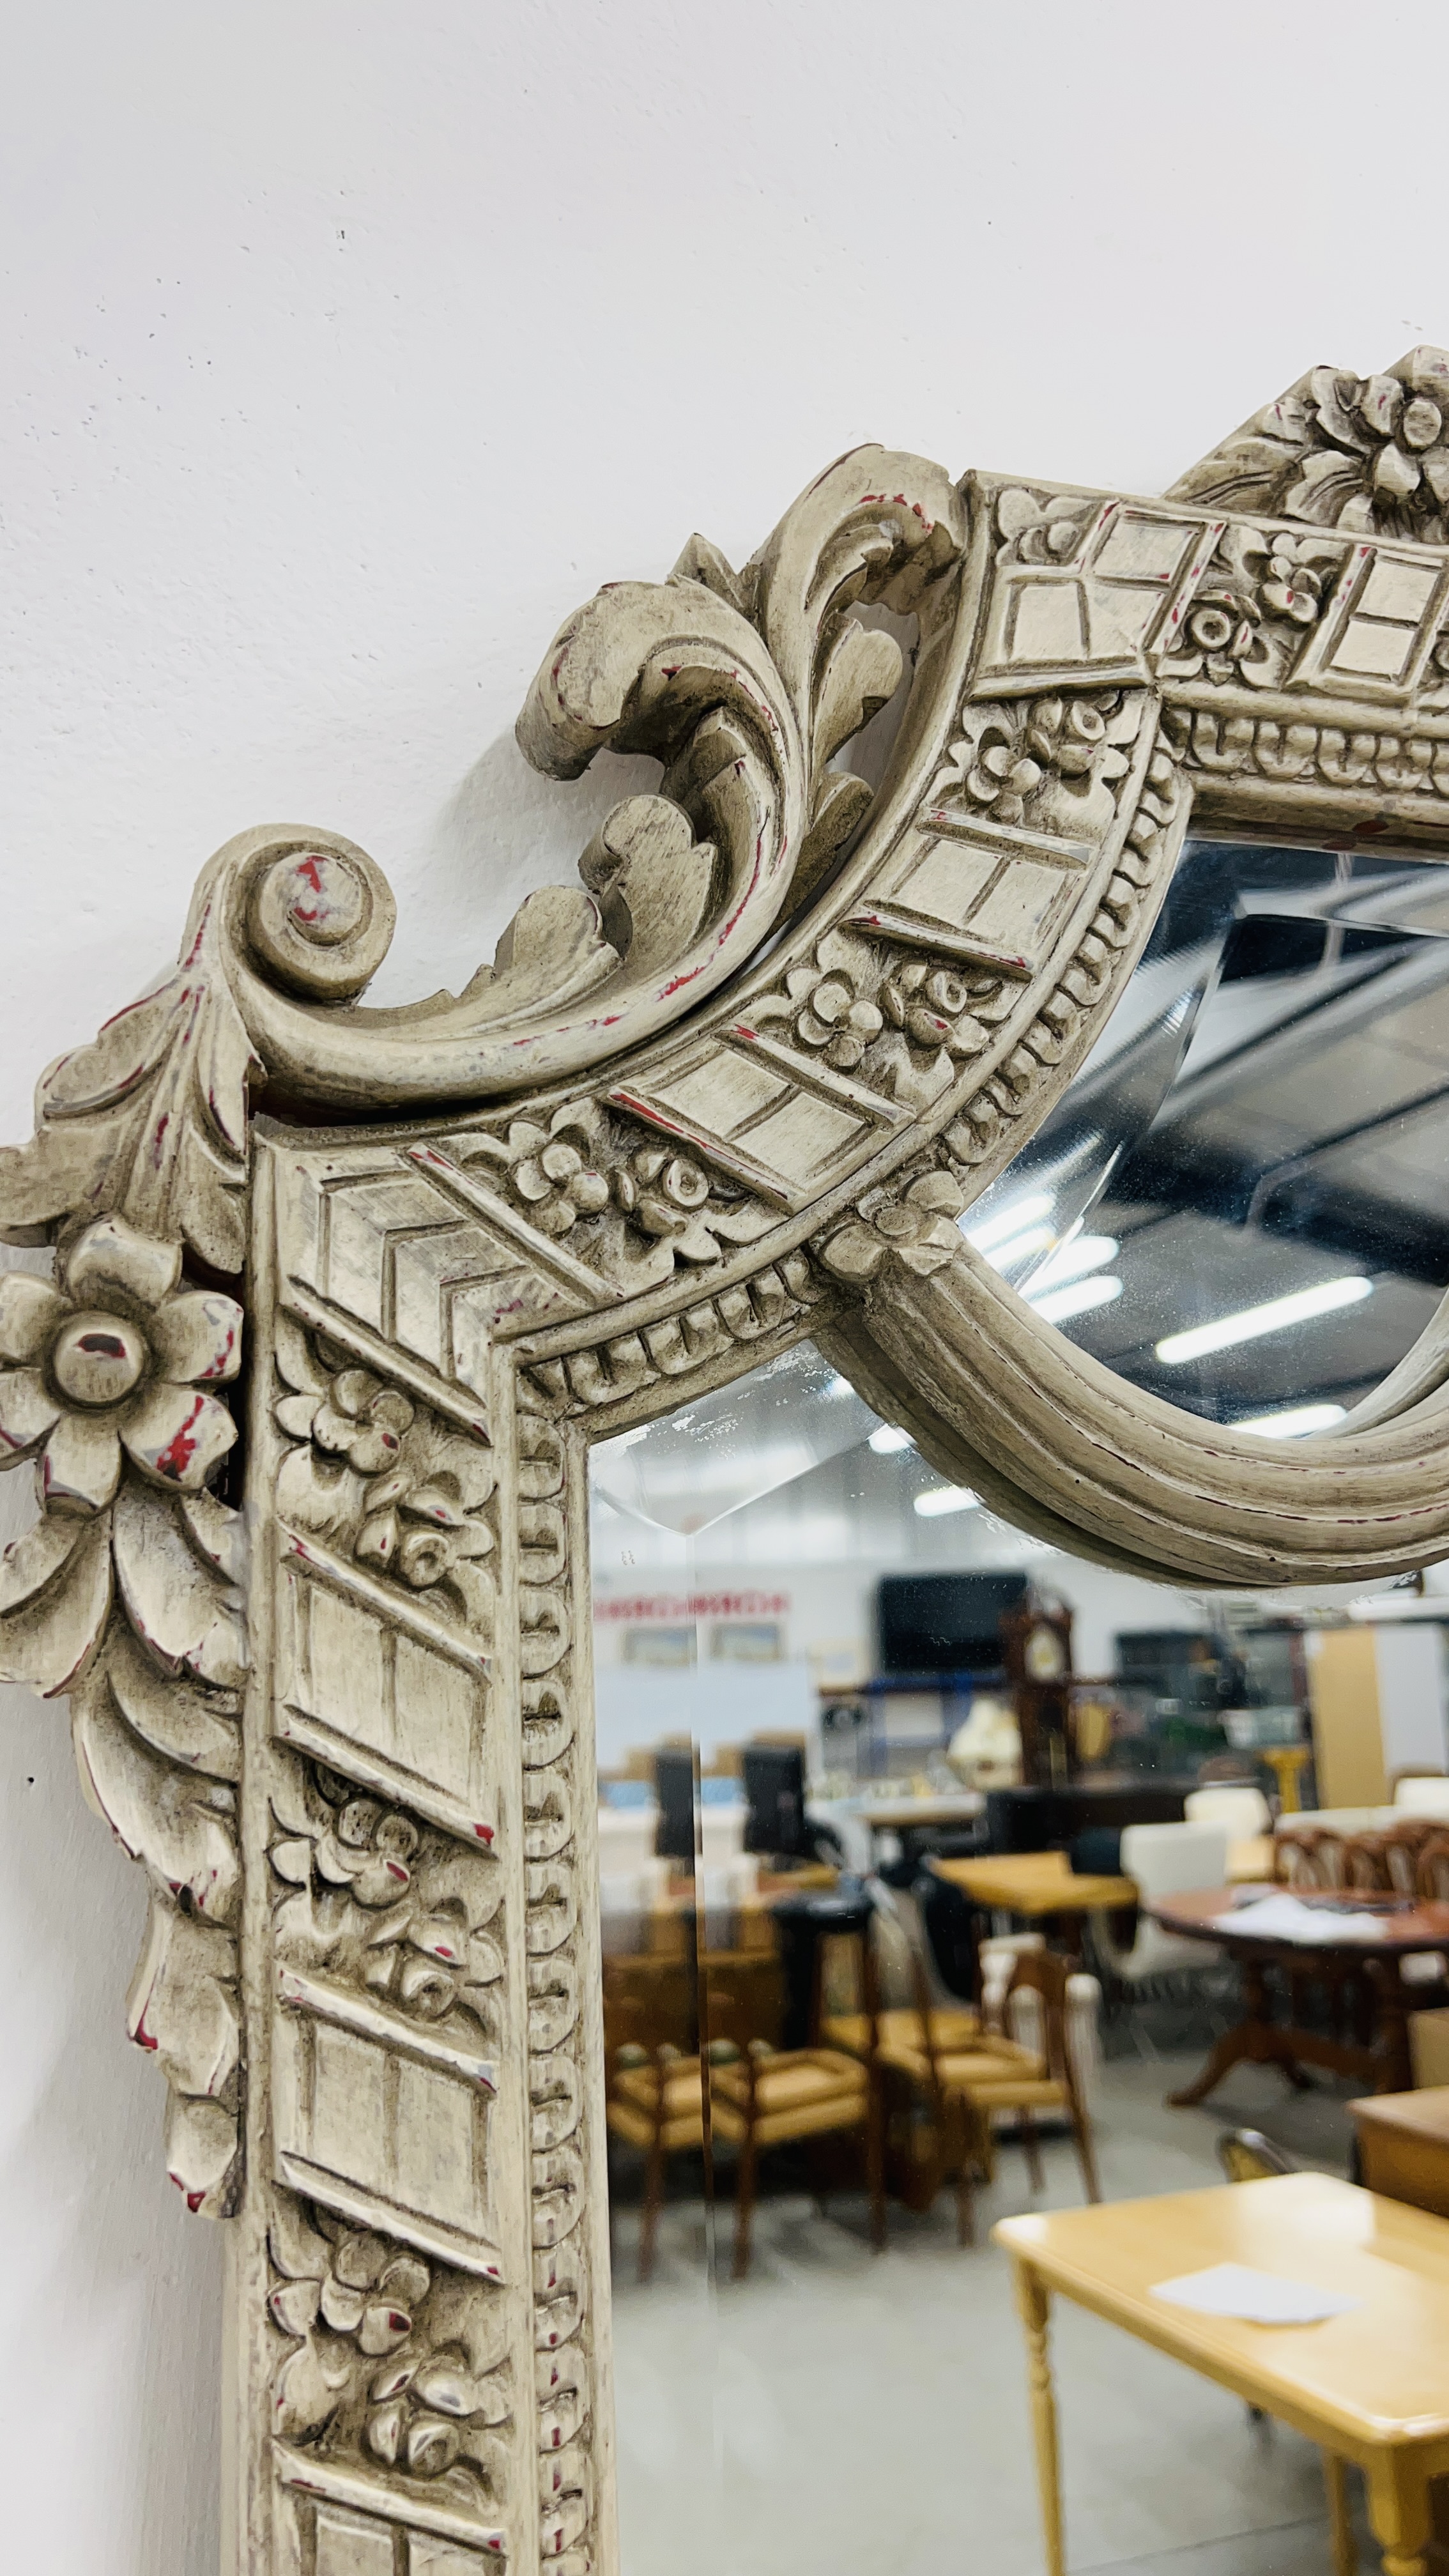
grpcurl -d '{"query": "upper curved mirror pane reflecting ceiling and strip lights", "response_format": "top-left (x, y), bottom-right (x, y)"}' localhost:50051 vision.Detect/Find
top-left (967, 839), bottom-right (1449, 1438)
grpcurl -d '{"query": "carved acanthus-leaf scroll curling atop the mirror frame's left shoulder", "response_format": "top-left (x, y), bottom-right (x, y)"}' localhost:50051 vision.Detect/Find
top-left (203, 448), bottom-right (964, 1108)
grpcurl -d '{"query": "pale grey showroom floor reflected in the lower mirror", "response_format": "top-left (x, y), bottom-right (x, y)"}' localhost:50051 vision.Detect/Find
top-left (603, 2058), bottom-right (1379, 2576)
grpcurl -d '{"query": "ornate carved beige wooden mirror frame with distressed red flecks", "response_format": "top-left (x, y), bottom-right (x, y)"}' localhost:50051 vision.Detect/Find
top-left (0, 350), bottom-right (1449, 2576)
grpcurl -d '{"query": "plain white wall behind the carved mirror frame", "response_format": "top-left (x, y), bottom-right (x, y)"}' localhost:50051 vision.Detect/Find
top-left (0, 0), bottom-right (1449, 2576)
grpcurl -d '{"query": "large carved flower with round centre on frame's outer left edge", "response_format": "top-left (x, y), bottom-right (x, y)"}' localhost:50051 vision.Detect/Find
top-left (0, 1216), bottom-right (242, 1512)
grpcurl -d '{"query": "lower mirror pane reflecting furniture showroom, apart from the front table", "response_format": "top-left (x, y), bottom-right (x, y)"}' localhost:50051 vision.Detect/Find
top-left (593, 1347), bottom-right (1449, 2576)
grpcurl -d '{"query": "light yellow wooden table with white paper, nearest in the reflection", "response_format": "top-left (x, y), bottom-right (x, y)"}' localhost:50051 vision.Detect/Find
top-left (993, 2174), bottom-right (1449, 2576)
